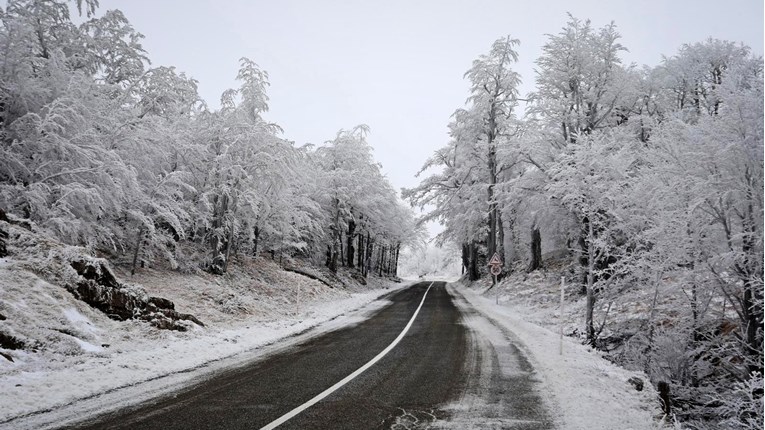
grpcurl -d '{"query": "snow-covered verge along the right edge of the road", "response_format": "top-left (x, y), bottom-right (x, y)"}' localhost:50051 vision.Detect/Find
top-left (458, 286), bottom-right (659, 430)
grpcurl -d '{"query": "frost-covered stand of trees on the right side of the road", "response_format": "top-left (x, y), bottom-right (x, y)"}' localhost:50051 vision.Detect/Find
top-left (404, 15), bottom-right (763, 428)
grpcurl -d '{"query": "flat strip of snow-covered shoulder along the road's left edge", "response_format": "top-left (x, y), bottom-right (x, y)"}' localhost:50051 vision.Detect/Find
top-left (0, 283), bottom-right (412, 430)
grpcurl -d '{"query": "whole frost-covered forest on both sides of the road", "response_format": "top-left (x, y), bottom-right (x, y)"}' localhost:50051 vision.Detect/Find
top-left (0, 0), bottom-right (765, 429)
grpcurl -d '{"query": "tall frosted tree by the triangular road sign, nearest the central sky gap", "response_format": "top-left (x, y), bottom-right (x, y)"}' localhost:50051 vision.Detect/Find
top-left (405, 36), bottom-right (520, 279)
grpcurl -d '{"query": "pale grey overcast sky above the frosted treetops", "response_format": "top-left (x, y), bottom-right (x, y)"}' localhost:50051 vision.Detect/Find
top-left (100, 0), bottom-right (763, 222)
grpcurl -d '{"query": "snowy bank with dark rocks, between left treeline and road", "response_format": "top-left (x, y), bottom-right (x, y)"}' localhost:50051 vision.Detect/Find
top-left (0, 221), bottom-right (400, 428)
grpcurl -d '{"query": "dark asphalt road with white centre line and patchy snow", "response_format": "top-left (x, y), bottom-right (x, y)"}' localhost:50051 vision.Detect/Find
top-left (71, 282), bottom-right (552, 429)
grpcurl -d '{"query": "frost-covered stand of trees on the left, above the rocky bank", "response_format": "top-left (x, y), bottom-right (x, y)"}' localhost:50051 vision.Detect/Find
top-left (0, 0), bottom-right (420, 276)
